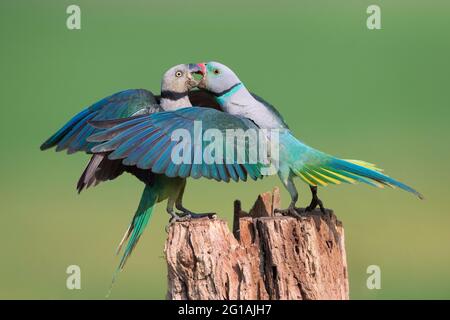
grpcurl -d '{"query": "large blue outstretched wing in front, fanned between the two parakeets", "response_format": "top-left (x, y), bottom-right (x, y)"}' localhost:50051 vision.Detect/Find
top-left (88, 107), bottom-right (264, 182)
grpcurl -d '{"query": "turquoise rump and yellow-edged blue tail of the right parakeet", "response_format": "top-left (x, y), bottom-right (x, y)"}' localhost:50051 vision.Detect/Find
top-left (280, 133), bottom-right (423, 199)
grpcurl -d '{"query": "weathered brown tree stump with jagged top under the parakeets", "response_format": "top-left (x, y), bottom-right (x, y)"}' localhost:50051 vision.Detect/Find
top-left (165, 188), bottom-right (349, 300)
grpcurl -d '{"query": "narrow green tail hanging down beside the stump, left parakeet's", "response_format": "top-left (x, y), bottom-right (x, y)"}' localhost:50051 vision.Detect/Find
top-left (111, 185), bottom-right (158, 292)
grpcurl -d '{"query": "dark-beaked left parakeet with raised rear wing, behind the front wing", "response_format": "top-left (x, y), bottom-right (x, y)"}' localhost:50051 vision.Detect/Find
top-left (41, 64), bottom-right (214, 269)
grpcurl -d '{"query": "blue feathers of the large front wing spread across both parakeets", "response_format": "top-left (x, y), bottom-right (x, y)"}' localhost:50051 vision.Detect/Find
top-left (90, 107), bottom-right (263, 182)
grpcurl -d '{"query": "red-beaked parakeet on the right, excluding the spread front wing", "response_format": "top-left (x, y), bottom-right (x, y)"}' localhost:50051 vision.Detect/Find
top-left (199, 62), bottom-right (423, 215)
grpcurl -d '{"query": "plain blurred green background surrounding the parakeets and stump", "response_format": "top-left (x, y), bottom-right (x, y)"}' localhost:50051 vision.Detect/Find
top-left (0, 0), bottom-right (450, 299)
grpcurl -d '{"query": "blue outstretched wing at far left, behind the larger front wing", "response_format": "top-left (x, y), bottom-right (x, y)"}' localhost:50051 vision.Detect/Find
top-left (41, 89), bottom-right (161, 154)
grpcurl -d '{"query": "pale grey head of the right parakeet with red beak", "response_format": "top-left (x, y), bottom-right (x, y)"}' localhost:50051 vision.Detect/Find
top-left (193, 61), bottom-right (241, 94)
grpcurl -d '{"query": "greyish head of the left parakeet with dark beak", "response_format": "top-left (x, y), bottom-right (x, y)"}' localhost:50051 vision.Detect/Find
top-left (161, 63), bottom-right (201, 93)
